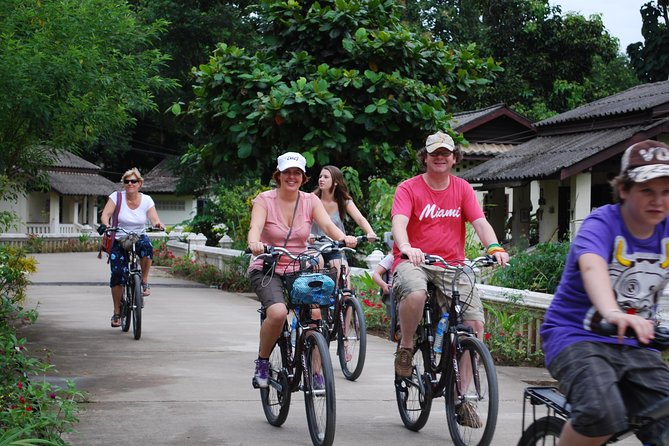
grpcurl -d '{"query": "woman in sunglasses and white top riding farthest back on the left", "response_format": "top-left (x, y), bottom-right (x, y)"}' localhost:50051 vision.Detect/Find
top-left (98, 167), bottom-right (165, 327)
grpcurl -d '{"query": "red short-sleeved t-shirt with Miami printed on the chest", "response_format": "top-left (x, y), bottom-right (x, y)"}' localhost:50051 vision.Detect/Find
top-left (392, 175), bottom-right (484, 271)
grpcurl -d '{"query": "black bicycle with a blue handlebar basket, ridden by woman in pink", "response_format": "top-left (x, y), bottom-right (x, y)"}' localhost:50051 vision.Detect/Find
top-left (247, 246), bottom-right (336, 446)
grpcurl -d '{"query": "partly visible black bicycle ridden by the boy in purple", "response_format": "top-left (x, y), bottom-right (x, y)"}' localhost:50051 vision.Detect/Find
top-left (518, 320), bottom-right (669, 446)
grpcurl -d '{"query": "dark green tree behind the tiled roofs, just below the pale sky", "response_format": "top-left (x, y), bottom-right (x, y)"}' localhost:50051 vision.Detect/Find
top-left (406, 0), bottom-right (636, 119)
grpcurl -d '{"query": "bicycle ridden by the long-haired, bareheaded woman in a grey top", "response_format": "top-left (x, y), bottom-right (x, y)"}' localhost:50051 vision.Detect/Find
top-left (316, 236), bottom-right (367, 381)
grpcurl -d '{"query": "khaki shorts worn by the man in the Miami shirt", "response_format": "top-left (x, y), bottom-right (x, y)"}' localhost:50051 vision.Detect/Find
top-left (393, 262), bottom-right (485, 322)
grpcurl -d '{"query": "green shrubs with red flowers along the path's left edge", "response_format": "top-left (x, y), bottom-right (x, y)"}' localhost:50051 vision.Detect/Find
top-left (0, 246), bottom-right (83, 445)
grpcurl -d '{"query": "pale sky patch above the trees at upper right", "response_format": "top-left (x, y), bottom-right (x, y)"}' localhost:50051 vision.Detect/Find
top-left (549, 0), bottom-right (648, 53)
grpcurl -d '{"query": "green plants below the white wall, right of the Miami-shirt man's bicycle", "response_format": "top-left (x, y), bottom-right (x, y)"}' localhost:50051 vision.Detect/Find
top-left (483, 295), bottom-right (543, 367)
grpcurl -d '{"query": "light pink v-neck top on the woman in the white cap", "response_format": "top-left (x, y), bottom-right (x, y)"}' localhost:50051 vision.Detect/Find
top-left (249, 189), bottom-right (319, 274)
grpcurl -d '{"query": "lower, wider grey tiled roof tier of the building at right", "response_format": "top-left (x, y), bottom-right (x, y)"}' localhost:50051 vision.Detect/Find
top-left (461, 126), bottom-right (644, 183)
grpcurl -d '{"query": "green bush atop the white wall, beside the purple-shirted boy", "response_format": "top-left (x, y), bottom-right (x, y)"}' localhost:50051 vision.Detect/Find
top-left (489, 241), bottom-right (569, 294)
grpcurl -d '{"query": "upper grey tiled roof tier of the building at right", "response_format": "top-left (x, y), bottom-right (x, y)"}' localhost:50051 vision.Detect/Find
top-left (535, 81), bottom-right (669, 128)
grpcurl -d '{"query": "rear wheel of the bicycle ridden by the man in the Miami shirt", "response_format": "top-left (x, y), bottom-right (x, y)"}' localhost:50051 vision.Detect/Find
top-left (395, 343), bottom-right (432, 432)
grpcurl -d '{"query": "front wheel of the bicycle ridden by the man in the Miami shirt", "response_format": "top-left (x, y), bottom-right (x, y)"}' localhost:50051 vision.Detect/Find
top-left (445, 336), bottom-right (499, 446)
